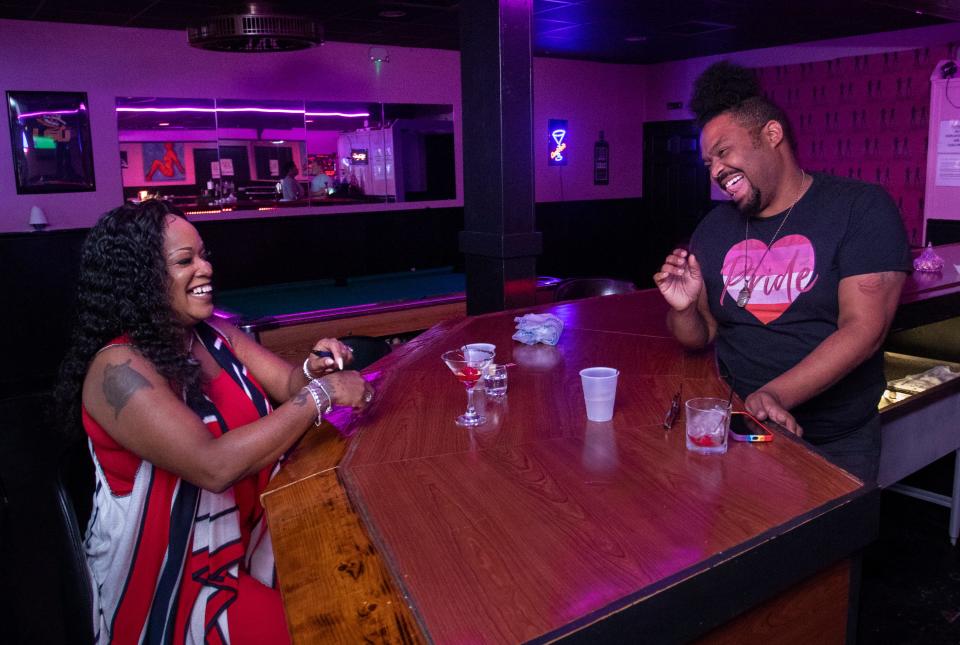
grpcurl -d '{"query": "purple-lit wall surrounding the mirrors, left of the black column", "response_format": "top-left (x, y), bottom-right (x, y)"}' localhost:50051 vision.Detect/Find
top-left (0, 20), bottom-right (462, 233)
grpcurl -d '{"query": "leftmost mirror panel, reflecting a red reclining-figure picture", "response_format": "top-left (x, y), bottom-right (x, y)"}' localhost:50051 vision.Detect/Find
top-left (116, 97), bottom-right (217, 210)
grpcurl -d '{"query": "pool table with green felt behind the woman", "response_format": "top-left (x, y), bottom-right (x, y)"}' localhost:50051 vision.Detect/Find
top-left (216, 267), bottom-right (560, 361)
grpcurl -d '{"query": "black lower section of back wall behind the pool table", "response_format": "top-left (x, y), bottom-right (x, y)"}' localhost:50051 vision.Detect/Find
top-left (0, 199), bottom-right (673, 399)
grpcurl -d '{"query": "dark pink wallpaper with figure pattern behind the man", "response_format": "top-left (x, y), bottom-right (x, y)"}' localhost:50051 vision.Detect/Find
top-left (757, 43), bottom-right (960, 246)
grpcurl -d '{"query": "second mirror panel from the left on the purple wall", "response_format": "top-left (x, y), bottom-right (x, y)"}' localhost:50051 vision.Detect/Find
top-left (216, 99), bottom-right (307, 210)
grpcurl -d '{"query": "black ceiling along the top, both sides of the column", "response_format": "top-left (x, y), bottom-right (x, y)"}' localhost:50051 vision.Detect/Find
top-left (0, 0), bottom-right (960, 63)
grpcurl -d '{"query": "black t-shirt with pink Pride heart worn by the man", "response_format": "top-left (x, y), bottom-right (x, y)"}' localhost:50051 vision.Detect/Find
top-left (690, 173), bottom-right (911, 442)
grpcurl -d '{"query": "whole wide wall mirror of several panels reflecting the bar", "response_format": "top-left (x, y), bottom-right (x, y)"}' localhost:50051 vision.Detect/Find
top-left (116, 97), bottom-right (456, 213)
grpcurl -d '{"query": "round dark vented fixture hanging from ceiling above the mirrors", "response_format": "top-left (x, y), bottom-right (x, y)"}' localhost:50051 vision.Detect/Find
top-left (187, 2), bottom-right (323, 54)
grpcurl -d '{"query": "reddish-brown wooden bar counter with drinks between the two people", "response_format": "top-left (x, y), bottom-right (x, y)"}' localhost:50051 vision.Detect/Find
top-left (263, 291), bottom-right (879, 643)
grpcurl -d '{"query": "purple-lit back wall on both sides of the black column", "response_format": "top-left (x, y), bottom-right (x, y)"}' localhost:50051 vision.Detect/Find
top-left (0, 20), bottom-right (644, 233)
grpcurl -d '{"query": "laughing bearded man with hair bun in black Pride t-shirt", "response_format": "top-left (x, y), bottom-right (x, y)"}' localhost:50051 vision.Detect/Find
top-left (654, 61), bottom-right (911, 481)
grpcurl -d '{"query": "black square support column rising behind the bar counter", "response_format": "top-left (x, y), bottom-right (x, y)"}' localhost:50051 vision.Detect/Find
top-left (460, 0), bottom-right (542, 315)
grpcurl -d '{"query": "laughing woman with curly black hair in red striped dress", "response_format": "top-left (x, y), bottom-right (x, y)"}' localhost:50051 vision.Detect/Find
top-left (57, 201), bottom-right (373, 643)
